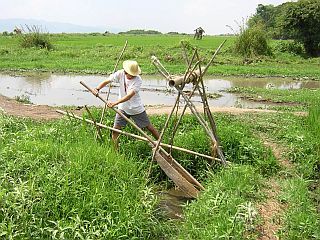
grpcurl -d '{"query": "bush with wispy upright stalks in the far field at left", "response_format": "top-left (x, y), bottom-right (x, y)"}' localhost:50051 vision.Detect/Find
top-left (21, 26), bottom-right (53, 50)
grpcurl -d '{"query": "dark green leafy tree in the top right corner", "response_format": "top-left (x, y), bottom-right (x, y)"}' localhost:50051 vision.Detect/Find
top-left (282, 0), bottom-right (320, 56)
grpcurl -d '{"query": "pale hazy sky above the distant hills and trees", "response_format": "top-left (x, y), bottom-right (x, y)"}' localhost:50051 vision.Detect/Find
top-left (0, 0), bottom-right (290, 34)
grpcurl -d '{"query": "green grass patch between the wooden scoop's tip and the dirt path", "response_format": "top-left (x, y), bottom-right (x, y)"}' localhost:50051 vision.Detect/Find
top-left (172, 166), bottom-right (262, 239)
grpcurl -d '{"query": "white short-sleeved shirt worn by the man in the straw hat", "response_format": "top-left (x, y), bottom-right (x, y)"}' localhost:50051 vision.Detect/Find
top-left (108, 69), bottom-right (145, 115)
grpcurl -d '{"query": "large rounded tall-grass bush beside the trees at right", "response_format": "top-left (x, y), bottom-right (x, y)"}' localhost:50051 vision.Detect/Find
top-left (235, 26), bottom-right (271, 57)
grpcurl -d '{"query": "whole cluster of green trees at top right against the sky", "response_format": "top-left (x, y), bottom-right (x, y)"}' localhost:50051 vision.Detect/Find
top-left (248, 0), bottom-right (320, 56)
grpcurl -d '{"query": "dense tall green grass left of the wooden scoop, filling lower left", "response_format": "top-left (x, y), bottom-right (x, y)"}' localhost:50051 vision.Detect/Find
top-left (0, 116), bottom-right (165, 239)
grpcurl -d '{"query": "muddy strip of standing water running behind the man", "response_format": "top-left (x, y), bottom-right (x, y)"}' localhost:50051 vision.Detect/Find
top-left (0, 73), bottom-right (320, 108)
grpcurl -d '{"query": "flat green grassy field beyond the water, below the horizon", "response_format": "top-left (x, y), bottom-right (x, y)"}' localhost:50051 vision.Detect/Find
top-left (0, 34), bottom-right (320, 79)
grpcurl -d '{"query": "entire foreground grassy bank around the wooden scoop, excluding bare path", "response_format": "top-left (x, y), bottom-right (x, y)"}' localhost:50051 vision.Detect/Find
top-left (0, 108), bottom-right (320, 239)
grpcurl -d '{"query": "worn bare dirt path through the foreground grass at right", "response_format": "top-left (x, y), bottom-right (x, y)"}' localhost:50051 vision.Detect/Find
top-left (257, 135), bottom-right (293, 240)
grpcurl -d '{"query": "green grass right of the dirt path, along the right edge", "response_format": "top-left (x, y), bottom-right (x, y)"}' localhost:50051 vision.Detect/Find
top-left (232, 113), bottom-right (320, 239)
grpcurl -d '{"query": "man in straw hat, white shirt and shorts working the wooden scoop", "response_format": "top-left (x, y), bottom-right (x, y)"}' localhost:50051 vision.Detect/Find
top-left (94, 60), bottom-right (159, 148)
